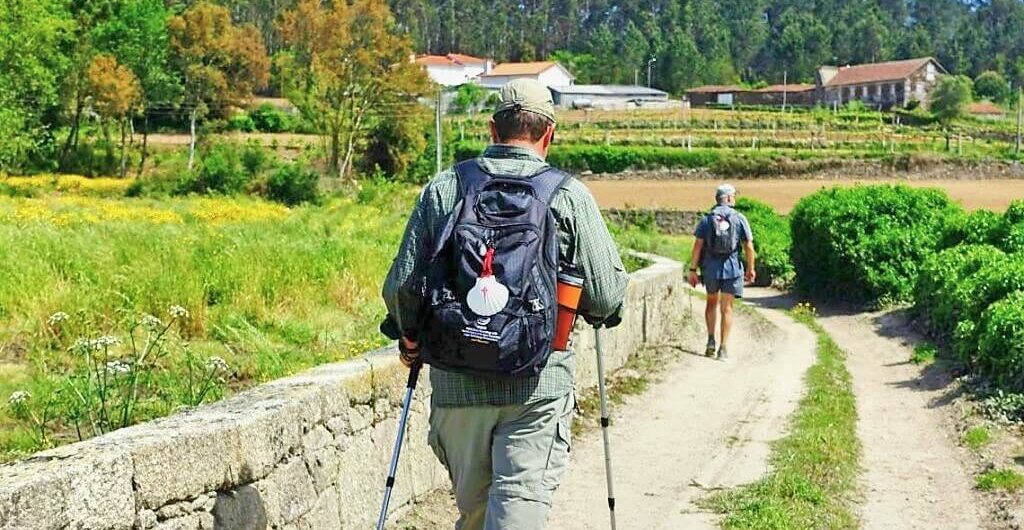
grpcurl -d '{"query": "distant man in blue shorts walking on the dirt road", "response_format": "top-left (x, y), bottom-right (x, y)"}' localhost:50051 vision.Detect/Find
top-left (689, 184), bottom-right (757, 361)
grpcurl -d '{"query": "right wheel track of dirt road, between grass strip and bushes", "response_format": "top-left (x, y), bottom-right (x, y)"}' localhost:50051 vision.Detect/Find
top-left (820, 314), bottom-right (991, 530)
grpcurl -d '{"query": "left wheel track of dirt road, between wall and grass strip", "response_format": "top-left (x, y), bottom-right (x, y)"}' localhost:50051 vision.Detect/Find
top-left (395, 295), bottom-right (815, 530)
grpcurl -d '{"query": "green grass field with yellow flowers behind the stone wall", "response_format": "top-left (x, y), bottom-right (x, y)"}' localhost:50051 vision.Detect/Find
top-left (0, 180), bottom-right (417, 460)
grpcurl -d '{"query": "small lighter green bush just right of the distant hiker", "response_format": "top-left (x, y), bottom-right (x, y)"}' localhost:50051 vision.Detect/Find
top-left (736, 197), bottom-right (795, 284)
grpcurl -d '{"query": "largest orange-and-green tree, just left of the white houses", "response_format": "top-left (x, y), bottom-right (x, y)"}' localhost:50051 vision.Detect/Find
top-left (280, 0), bottom-right (429, 178)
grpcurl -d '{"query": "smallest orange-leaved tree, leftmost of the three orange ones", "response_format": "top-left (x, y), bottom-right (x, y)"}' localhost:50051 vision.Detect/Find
top-left (88, 54), bottom-right (142, 177)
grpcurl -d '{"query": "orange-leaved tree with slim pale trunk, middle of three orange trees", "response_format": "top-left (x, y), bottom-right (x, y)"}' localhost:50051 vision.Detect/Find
top-left (167, 0), bottom-right (269, 171)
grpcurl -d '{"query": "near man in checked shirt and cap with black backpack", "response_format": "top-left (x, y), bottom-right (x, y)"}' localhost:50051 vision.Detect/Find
top-left (383, 80), bottom-right (628, 530)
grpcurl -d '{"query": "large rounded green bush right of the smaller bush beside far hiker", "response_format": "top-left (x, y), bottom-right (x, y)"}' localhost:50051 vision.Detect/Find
top-left (790, 185), bottom-right (959, 303)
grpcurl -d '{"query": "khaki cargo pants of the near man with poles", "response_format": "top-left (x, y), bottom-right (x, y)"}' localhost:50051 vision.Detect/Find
top-left (429, 393), bottom-right (574, 530)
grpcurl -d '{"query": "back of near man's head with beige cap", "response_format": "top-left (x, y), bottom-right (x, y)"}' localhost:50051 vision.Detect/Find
top-left (492, 79), bottom-right (555, 142)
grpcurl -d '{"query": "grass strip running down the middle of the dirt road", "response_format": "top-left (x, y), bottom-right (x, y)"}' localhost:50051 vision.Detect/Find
top-left (701, 311), bottom-right (860, 530)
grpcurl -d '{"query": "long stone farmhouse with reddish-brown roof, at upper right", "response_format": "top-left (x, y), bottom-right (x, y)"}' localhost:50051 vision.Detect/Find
top-left (816, 57), bottom-right (946, 109)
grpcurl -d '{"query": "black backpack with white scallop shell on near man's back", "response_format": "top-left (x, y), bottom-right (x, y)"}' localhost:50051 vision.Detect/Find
top-left (420, 160), bottom-right (568, 378)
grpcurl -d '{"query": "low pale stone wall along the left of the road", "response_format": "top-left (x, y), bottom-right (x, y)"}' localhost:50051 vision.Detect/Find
top-left (0, 258), bottom-right (688, 530)
